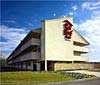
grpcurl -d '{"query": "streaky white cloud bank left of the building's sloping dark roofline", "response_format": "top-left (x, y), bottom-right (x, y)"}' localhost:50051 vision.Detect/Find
top-left (0, 25), bottom-right (26, 57)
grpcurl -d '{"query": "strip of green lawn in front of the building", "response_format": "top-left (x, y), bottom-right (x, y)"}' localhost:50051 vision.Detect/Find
top-left (0, 71), bottom-right (75, 84)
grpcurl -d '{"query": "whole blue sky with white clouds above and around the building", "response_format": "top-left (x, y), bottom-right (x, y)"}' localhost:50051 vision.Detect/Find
top-left (0, 0), bottom-right (100, 62)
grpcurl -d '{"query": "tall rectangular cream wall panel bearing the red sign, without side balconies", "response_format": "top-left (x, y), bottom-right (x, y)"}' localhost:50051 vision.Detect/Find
top-left (45, 17), bottom-right (73, 61)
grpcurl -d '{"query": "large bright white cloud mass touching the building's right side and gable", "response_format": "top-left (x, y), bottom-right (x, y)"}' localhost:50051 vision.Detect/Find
top-left (74, 13), bottom-right (100, 62)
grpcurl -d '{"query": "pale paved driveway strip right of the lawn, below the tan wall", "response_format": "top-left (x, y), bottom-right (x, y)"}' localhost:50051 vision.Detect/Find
top-left (65, 70), bottom-right (100, 77)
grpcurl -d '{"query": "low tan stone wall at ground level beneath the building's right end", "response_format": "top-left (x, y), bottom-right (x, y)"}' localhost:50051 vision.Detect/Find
top-left (54, 63), bottom-right (94, 71)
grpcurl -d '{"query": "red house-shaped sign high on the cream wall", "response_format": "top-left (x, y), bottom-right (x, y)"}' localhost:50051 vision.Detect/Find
top-left (63, 20), bottom-right (73, 40)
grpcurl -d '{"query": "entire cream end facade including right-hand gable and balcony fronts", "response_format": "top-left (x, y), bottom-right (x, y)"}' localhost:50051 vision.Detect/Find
top-left (43, 17), bottom-right (89, 61)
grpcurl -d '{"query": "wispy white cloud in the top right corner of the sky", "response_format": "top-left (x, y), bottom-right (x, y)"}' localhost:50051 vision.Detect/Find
top-left (82, 1), bottom-right (100, 10)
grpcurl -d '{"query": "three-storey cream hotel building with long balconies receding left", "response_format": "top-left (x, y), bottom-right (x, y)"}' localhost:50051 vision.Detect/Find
top-left (7, 17), bottom-right (89, 71)
